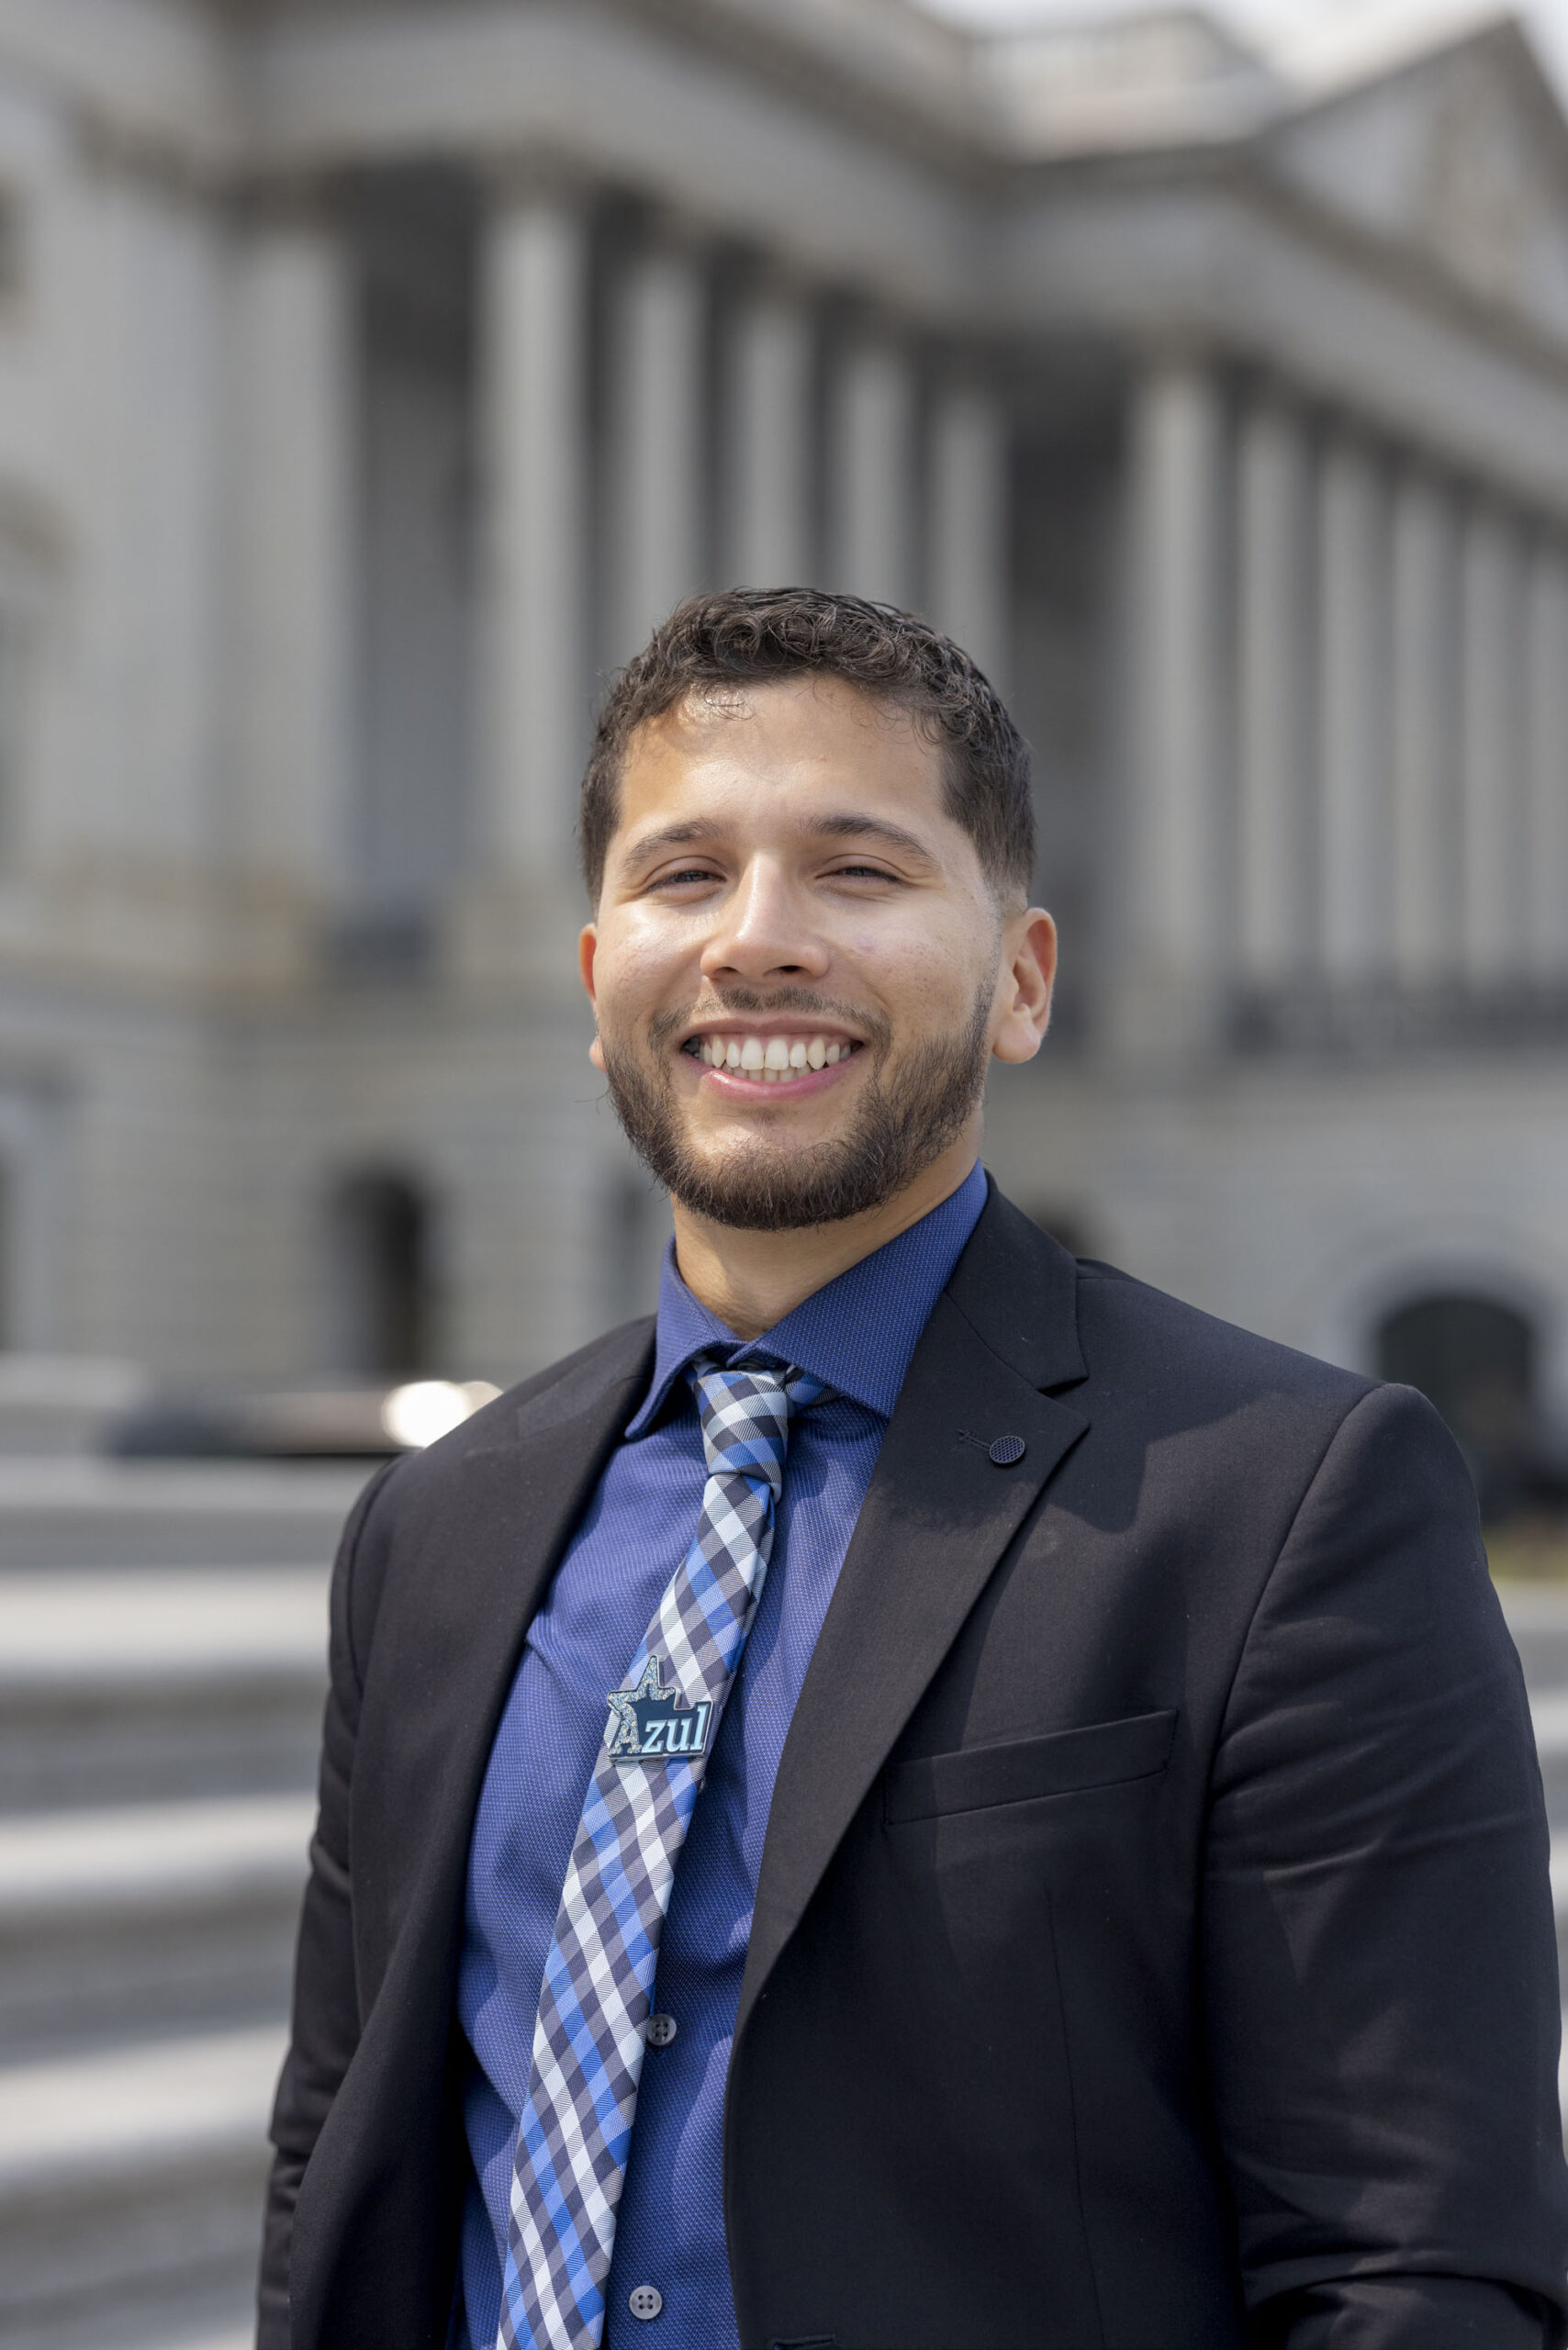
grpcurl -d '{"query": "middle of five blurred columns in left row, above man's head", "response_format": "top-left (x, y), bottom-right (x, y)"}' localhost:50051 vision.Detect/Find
top-left (724, 280), bottom-right (813, 588)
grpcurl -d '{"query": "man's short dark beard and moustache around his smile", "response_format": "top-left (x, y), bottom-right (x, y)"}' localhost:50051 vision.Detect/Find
top-left (599, 982), bottom-right (992, 1231)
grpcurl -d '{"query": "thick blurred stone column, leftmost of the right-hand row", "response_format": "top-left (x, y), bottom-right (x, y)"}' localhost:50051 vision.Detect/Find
top-left (1116, 352), bottom-right (1227, 1058)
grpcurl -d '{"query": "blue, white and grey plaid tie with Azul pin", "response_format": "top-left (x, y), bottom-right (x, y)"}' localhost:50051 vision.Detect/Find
top-left (496, 1356), bottom-right (827, 2350)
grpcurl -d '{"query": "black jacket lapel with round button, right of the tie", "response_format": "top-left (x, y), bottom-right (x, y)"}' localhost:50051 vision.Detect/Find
top-left (736, 1192), bottom-right (1089, 2040)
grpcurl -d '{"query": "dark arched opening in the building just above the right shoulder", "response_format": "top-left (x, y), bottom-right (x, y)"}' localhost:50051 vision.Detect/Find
top-left (1378, 1290), bottom-right (1544, 1518)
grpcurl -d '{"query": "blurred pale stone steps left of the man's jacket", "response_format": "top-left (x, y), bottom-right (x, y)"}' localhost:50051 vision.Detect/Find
top-left (0, 1457), bottom-right (364, 2350)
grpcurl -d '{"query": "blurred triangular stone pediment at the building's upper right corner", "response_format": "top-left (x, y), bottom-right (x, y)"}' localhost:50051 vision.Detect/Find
top-left (1262, 21), bottom-right (1568, 341)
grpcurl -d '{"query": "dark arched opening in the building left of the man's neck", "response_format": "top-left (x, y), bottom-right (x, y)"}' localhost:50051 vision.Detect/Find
top-left (327, 1170), bottom-right (432, 1380)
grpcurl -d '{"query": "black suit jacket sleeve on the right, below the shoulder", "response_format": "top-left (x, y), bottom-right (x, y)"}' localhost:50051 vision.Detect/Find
top-left (1202, 1386), bottom-right (1568, 2350)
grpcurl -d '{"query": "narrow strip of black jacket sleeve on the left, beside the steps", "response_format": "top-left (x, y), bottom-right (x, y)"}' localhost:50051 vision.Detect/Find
top-left (256, 1461), bottom-right (395, 2350)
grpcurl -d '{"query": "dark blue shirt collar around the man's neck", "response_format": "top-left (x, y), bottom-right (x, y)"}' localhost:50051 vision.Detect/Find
top-left (625, 1166), bottom-right (988, 1438)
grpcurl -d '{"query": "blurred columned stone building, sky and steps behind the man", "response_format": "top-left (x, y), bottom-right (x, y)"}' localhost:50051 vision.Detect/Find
top-left (0, 0), bottom-right (1568, 2350)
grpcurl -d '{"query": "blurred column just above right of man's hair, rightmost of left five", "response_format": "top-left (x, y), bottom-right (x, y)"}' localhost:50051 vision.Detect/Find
top-left (928, 376), bottom-right (1014, 693)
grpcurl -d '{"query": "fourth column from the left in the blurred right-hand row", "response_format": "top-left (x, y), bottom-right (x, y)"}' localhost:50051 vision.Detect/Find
top-left (1392, 463), bottom-right (1460, 990)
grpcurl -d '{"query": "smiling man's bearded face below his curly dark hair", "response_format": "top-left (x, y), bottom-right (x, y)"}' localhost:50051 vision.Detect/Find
top-left (583, 677), bottom-right (1048, 1229)
